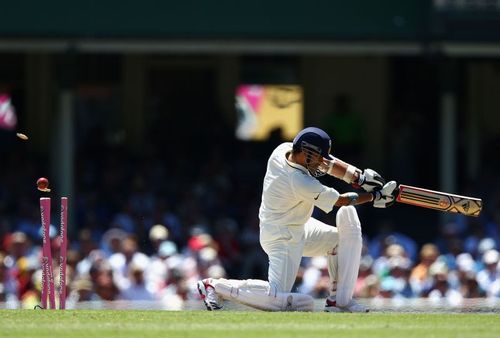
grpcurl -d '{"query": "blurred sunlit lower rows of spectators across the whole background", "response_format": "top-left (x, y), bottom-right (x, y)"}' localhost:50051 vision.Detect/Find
top-left (0, 215), bottom-right (500, 310)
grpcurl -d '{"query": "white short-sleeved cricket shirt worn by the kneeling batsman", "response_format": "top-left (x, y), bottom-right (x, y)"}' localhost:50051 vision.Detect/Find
top-left (259, 142), bottom-right (339, 225)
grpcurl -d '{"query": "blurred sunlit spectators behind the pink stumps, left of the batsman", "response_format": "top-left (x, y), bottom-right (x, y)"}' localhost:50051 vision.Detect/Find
top-left (0, 224), bottom-right (234, 309)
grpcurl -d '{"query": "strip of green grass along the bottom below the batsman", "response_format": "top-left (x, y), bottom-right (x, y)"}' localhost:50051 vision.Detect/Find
top-left (0, 310), bottom-right (500, 338)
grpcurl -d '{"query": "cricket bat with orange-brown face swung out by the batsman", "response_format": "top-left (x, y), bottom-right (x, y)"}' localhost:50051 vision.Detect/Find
top-left (396, 184), bottom-right (483, 217)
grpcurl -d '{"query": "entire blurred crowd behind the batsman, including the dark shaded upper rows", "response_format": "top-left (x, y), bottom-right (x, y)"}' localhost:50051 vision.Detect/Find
top-left (0, 128), bottom-right (500, 309)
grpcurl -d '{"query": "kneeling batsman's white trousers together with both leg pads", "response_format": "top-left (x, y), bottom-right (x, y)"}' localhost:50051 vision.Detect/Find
top-left (210, 206), bottom-right (362, 311)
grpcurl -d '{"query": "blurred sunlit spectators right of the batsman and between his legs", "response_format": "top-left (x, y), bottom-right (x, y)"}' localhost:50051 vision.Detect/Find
top-left (299, 223), bottom-right (500, 305)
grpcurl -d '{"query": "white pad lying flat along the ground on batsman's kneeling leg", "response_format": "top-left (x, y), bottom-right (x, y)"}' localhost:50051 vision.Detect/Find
top-left (211, 278), bottom-right (314, 311)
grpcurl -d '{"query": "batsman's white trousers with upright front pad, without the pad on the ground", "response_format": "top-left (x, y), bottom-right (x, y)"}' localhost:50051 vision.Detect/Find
top-left (260, 206), bottom-right (362, 306)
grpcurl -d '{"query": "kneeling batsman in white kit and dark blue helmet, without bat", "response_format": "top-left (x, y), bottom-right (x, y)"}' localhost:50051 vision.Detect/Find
top-left (197, 127), bottom-right (397, 312)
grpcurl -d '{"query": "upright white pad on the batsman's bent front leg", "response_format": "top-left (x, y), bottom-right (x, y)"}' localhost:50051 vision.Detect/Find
top-left (336, 206), bottom-right (363, 306)
